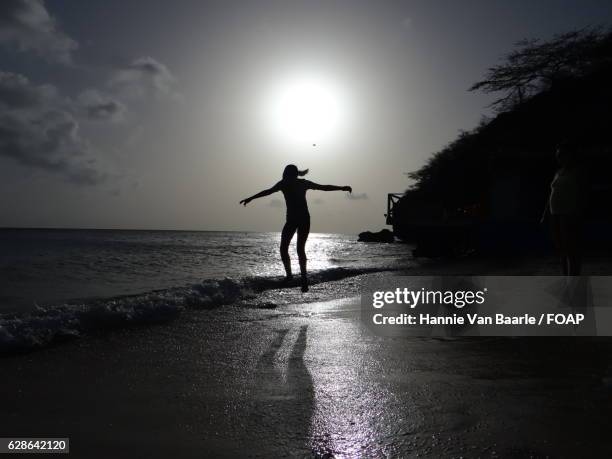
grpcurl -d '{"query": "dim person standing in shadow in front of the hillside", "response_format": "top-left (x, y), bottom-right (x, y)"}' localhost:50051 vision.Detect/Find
top-left (541, 143), bottom-right (585, 276)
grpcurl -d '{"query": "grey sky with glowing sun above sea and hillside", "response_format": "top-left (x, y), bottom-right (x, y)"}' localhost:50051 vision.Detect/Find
top-left (0, 0), bottom-right (612, 233)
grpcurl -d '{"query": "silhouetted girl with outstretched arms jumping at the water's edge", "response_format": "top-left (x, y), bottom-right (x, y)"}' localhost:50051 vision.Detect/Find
top-left (240, 164), bottom-right (353, 292)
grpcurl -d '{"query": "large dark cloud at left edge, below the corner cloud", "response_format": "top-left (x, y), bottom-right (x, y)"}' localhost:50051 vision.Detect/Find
top-left (0, 72), bottom-right (109, 185)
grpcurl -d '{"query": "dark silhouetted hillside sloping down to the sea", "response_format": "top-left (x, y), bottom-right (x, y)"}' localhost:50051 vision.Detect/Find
top-left (394, 28), bottom-right (612, 253)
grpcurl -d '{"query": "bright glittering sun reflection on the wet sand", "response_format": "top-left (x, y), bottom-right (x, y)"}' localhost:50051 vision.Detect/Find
top-left (306, 310), bottom-right (402, 457)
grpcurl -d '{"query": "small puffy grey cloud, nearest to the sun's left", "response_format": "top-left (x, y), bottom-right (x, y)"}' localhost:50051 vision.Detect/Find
top-left (109, 57), bottom-right (180, 98)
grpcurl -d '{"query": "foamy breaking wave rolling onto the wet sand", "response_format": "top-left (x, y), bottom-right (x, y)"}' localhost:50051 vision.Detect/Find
top-left (0, 268), bottom-right (392, 354)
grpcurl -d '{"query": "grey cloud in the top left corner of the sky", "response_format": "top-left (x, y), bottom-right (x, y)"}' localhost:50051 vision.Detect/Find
top-left (0, 0), bottom-right (78, 64)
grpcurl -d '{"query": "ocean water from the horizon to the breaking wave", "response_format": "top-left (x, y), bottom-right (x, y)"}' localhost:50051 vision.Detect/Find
top-left (0, 229), bottom-right (411, 352)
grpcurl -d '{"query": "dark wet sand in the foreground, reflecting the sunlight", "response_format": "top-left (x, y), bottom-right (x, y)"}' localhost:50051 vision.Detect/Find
top-left (0, 256), bottom-right (612, 458)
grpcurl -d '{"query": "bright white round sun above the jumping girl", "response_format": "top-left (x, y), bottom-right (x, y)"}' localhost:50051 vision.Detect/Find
top-left (266, 76), bottom-right (347, 145)
